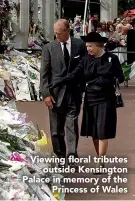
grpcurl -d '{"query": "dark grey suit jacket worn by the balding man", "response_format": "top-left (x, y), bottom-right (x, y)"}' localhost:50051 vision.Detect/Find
top-left (40, 38), bottom-right (87, 107)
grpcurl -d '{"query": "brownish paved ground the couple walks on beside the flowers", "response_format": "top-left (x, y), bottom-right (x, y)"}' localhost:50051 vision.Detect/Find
top-left (17, 81), bottom-right (135, 200)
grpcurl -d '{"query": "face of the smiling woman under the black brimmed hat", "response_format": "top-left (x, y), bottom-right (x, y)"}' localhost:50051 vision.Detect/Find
top-left (86, 42), bottom-right (101, 56)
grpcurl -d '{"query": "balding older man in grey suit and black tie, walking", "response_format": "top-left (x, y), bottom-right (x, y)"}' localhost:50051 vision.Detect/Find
top-left (40, 19), bottom-right (87, 166)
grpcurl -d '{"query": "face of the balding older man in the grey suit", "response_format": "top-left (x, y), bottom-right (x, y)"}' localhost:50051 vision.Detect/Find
top-left (54, 24), bottom-right (70, 42)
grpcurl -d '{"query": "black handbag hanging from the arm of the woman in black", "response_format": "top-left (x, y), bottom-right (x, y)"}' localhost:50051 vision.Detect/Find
top-left (115, 79), bottom-right (124, 108)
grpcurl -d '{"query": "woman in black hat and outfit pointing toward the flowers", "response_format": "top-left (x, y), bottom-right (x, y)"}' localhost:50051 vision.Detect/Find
top-left (50, 32), bottom-right (124, 170)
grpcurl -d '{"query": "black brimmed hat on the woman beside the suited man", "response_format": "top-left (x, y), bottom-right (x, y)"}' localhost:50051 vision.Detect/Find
top-left (81, 32), bottom-right (108, 43)
